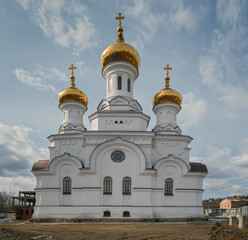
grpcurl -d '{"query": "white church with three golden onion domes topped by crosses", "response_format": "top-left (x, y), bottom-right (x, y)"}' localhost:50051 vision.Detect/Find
top-left (32, 13), bottom-right (207, 220)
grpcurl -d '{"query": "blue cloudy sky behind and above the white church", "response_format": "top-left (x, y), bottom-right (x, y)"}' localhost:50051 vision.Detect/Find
top-left (0, 0), bottom-right (248, 199)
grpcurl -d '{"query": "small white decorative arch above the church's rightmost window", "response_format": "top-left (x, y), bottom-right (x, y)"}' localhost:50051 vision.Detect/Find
top-left (153, 154), bottom-right (189, 175)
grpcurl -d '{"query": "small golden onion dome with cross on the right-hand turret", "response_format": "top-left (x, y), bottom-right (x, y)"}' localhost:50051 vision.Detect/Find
top-left (152, 64), bottom-right (182, 106)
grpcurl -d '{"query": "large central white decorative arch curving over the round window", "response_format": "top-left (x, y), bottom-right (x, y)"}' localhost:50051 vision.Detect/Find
top-left (90, 137), bottom-right (146, 173)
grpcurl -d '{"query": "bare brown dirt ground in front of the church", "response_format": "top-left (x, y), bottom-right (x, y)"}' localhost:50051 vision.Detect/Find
top-left (0, 221), bottom-right (248, 240)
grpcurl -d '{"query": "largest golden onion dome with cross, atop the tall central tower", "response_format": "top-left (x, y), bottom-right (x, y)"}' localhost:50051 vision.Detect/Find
top-left (101, 13), bottom-right (140, 69)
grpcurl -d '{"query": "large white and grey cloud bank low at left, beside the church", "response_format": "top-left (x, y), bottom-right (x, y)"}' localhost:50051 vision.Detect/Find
top-left (0, 122), bottom-right (48, 190)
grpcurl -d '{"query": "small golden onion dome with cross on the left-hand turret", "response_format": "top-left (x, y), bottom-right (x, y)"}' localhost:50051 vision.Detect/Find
top-left (58, 64), bottom-right (88, 107)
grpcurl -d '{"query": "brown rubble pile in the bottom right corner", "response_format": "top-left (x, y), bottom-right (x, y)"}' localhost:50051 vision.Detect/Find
top-left (208, 223), bottom-right (248, 240)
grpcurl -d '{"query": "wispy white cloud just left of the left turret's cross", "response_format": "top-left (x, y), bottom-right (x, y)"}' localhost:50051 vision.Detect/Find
top-left (14, 66), bottom-right (68, 93)
